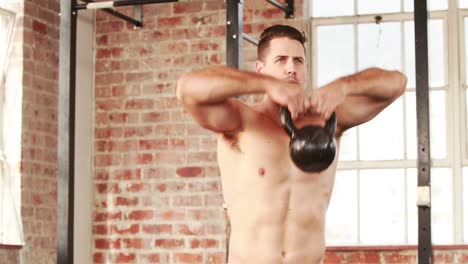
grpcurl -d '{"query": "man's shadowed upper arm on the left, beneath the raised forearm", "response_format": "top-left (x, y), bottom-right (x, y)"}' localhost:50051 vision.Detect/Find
top-left (185, 99), bottom-right (242, 133)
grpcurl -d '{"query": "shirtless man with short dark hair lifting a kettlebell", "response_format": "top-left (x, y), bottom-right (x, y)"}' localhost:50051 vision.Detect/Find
top-left (177, 25), bottom-right (406, 264)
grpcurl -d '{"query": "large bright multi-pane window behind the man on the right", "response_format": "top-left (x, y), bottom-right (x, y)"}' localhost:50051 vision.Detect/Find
top-left (310, 0), bottom-right (468, 246)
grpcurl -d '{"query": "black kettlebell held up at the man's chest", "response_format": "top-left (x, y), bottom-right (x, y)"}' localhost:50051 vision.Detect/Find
top-left (280, 107), bottom-right (336, 172)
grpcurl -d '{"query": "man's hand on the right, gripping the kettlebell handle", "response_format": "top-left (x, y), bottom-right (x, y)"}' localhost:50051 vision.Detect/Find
top-left (309, 82), bottom-right (346, 120)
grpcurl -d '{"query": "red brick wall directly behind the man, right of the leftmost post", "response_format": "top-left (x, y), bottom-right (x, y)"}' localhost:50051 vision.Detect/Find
top-left (93, 0), bottom-right (304, 263)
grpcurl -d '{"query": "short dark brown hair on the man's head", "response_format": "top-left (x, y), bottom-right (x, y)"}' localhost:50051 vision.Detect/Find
top-left (257, 25), bottom-right (307, 60)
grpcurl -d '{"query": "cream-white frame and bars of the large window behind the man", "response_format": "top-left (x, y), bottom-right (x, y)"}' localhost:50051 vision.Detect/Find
top-left (309, 0), bottom-right (468, 246)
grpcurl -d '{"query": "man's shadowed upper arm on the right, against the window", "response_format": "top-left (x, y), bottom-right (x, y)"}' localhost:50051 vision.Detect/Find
top-left (336, 96), bottom-right (392, 133)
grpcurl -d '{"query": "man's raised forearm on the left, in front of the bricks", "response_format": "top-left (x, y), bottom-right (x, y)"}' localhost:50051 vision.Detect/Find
top-left (177, 66), bottom-right (273, 104)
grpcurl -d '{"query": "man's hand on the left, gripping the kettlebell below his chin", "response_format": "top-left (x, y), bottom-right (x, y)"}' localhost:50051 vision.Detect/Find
top-left (266, 81), bottom-right (311, 119)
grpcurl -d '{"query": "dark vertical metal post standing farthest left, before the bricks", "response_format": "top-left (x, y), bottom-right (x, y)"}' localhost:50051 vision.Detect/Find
top-left (57, 0), bottom-right (78, 264)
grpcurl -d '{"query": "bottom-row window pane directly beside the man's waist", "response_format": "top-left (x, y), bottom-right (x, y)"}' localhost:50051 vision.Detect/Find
top-left (326, 170), bottom-right (358, 245)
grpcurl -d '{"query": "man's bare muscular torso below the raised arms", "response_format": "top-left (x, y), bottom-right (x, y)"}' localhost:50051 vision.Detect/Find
top-left (218, 101), bottom-right (339, 264)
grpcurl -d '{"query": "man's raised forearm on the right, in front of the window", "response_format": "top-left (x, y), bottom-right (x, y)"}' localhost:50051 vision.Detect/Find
top-left (337, 68), bottom-right (407, 101)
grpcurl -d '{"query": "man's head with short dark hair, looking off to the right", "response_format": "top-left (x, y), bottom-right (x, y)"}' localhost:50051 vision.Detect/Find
top-left (255, 25), bottom-right (307, 86)
